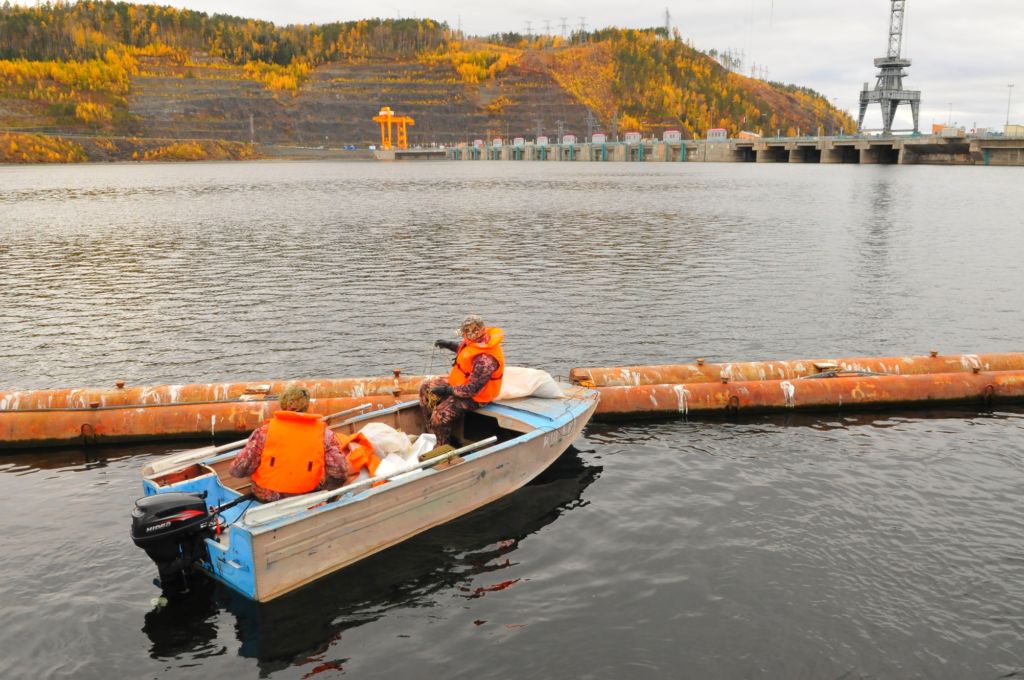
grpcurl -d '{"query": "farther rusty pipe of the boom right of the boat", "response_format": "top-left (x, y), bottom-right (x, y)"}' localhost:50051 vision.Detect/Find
top-left (569, 352), bottom-right (1024, 387)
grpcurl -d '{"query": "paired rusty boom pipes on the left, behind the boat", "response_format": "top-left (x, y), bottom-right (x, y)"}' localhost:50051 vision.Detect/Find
top-left (0, 371), bottom-right (425, 451)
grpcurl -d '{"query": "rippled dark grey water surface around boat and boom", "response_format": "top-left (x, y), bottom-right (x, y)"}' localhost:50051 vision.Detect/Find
top-left (0, 163), bottom-right (1024, 679)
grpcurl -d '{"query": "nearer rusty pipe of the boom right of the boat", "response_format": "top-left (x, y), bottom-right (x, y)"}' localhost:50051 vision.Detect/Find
top-left (595, 371), bottom-right (1024, 418)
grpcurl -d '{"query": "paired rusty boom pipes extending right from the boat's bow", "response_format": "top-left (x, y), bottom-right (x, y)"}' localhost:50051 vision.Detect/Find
top-left (569, 352), bottom-right (1024, 419)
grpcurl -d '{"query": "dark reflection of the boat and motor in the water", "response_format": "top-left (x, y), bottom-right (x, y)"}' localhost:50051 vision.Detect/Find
top-left (142, 448), bottom-right (602, 674)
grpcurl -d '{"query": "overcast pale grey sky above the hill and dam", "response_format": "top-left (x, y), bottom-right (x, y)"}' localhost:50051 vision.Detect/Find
top-left (163, 0), bottom-right (1024, 130)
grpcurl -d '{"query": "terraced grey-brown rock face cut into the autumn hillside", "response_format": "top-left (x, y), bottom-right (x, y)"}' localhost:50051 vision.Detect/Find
top-left (128, 50), bottom-right (586, 146)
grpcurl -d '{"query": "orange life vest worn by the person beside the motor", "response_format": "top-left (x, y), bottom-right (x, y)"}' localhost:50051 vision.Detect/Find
top-left (253, 411), bottom-right (327, 494)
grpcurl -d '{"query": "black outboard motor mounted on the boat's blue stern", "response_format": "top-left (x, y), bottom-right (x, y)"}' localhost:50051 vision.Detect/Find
top-left (131, 492), bottom-right (214, 595)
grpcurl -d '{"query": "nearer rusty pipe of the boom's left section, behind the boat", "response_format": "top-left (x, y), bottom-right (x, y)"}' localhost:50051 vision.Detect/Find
top-left (0, 394), bottom-right (407, 451)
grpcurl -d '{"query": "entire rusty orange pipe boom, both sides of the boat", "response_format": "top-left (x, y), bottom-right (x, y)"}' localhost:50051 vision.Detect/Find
top-left (0, 352), bottom-right (1024, 451)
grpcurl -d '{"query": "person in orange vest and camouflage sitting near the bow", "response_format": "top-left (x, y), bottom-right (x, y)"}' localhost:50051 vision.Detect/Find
top-left (420, 314), bottom-right (505, 447)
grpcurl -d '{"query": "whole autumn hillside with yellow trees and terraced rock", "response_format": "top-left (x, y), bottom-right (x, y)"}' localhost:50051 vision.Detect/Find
top-left (0, 2), bottom-right (852, 162)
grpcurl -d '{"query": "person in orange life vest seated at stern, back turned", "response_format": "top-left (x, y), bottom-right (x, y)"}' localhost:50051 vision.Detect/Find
top-left (230, 385), bottom-right (348, 503)
